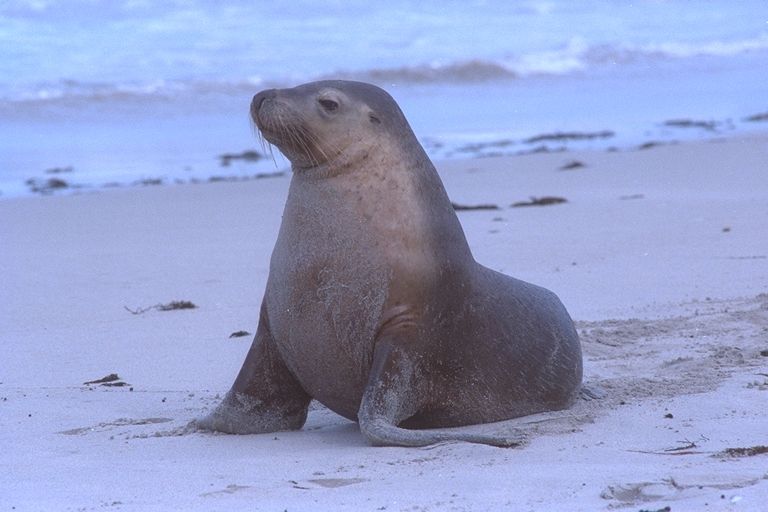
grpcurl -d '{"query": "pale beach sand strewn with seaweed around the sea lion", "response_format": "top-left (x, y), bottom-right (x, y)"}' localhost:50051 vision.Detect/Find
top-left (0, 135), bottom-right (768, 512)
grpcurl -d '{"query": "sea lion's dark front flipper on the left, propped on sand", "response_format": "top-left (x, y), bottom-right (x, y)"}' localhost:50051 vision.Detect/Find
top-left (190, 305), bottom-right (311, 434)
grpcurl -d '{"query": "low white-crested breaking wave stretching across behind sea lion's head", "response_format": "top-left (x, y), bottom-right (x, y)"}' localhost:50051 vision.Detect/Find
top-left (0, 34), bottom-right (768, 107)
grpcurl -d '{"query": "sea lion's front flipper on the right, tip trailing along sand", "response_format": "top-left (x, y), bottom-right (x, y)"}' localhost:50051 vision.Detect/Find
top-left (357, 339), bottom-right (525, 447)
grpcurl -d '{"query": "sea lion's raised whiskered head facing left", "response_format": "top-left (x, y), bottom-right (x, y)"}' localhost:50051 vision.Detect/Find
top-left (251, 80), bottom-right (418, 171)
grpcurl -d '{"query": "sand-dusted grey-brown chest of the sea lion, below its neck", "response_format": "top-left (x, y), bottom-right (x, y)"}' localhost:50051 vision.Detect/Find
top-left (266, 180), bottom-right (391, 407)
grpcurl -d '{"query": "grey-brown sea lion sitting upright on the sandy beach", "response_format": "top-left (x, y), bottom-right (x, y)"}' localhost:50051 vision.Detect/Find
top-left (196, 80), bottom-right (582, 446)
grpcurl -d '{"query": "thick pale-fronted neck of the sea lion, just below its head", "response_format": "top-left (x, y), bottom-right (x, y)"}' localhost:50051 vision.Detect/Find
top-left (291, 142), bottom-right (472, 263)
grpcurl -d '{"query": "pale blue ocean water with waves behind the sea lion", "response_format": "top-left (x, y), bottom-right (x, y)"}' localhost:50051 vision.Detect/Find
top-left (0, 0), bottom-right (768, 197)
